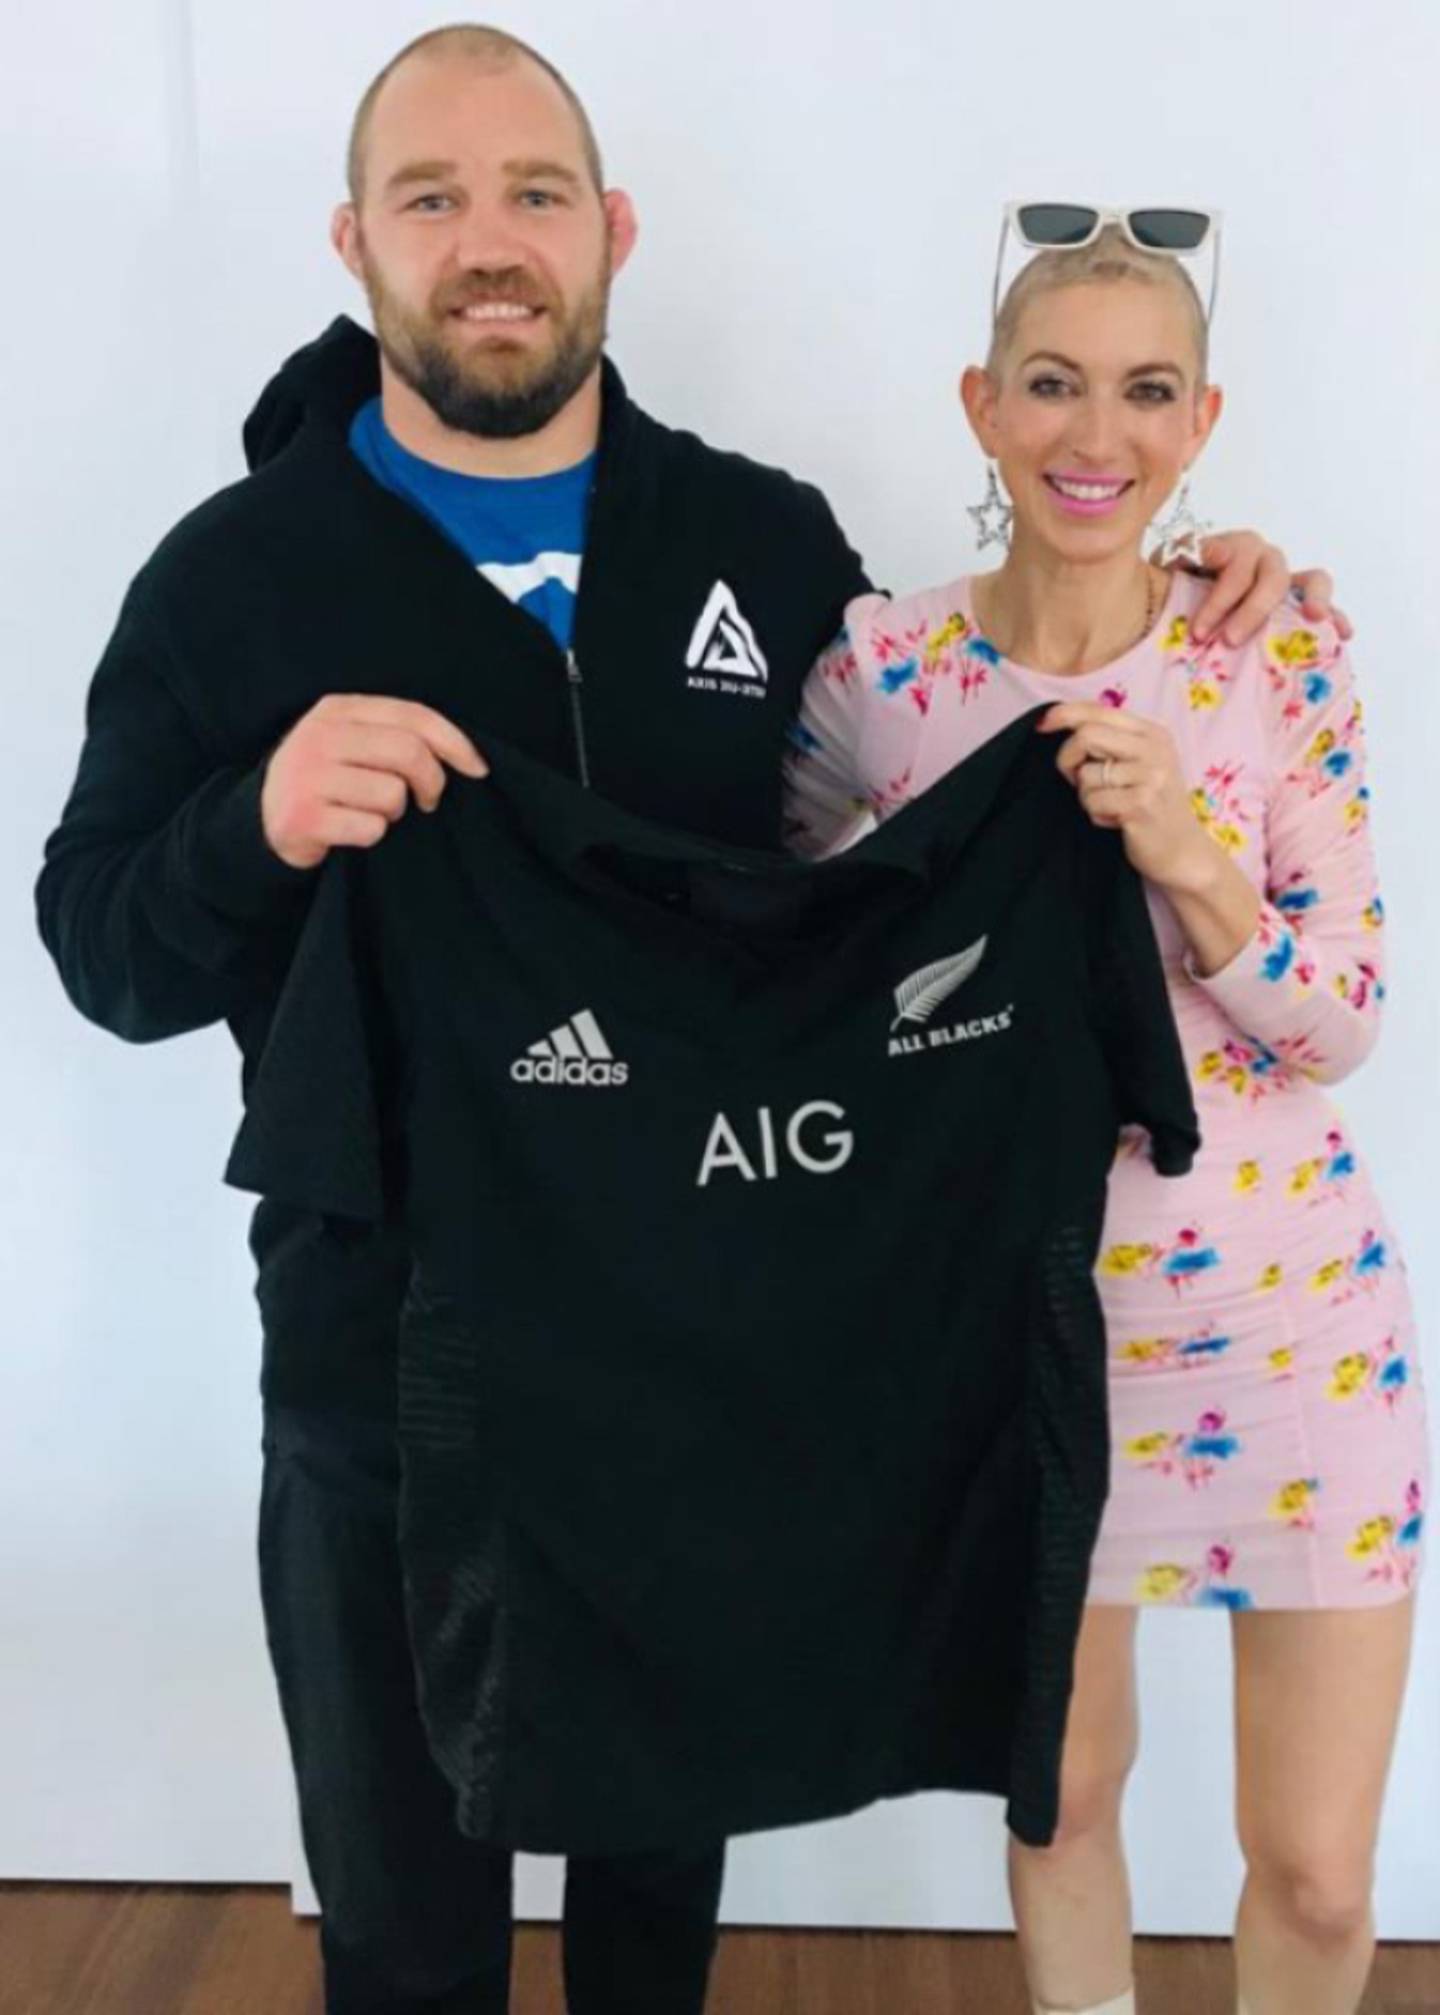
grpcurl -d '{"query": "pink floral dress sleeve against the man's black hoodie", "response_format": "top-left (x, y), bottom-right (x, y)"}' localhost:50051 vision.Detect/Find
top-left (781, 596), bottom-right (882, 860)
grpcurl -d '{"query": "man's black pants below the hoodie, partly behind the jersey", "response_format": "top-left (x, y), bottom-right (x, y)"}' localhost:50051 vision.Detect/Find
top-left (260, 1406), bottom-right (725, 2015)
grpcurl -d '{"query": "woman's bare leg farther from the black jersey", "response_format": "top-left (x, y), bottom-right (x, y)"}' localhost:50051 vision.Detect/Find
top-left (1235, 1598), bottom-right (1414, 2015)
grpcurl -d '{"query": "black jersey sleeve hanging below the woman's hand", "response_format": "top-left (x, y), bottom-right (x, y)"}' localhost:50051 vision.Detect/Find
top-left (1079, 820), bottom-right (1200, 1175)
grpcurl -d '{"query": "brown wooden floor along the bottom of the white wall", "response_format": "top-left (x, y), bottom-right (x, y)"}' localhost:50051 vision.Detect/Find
top-left (0, 1882), bottom-right (1440, 2015)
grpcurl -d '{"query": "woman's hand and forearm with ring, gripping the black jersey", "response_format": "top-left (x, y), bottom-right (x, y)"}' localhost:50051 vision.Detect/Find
top-left (1037, 699), bottom-right (1261, 975)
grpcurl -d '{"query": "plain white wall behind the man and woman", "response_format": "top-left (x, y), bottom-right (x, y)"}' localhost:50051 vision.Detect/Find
top-left (0, 0), bottom-right (1440, 1938)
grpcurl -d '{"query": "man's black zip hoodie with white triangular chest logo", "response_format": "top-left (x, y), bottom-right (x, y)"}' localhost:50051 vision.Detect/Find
top-left (36, 316), bottom-right (868, 1419)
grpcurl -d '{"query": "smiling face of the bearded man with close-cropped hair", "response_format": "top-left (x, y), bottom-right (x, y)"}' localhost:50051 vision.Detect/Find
top-left (336, 56), bottom-right (632, 439)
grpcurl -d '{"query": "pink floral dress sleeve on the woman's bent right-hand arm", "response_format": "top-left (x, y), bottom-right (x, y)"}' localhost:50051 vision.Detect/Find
top-left (1186, 613), bottom-right (1386, 1084)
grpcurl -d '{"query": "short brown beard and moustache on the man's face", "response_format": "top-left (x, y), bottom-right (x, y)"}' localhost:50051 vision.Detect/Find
top-left (361, 252), bottom-right (610, 441)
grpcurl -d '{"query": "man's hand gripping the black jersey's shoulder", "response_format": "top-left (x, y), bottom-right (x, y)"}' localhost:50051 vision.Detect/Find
top-left (260, 693), bottom-right (489, 868)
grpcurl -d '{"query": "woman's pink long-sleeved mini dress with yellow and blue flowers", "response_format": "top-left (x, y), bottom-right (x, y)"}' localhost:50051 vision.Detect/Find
top-left (785, 574), bottom-right (1428, 1608)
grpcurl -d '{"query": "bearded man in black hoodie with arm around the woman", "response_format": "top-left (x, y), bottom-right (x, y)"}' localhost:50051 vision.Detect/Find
top-left (38, 28), bottom-right (1327, 2015)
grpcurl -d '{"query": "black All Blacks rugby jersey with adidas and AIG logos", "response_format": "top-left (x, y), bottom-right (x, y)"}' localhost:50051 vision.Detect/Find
top-left (228, 713), bottom-right (1198, 1854)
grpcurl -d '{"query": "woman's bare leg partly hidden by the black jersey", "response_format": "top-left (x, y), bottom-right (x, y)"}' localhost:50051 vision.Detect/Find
top-left (1009, 1604), bottom-right (1140, 2009)
